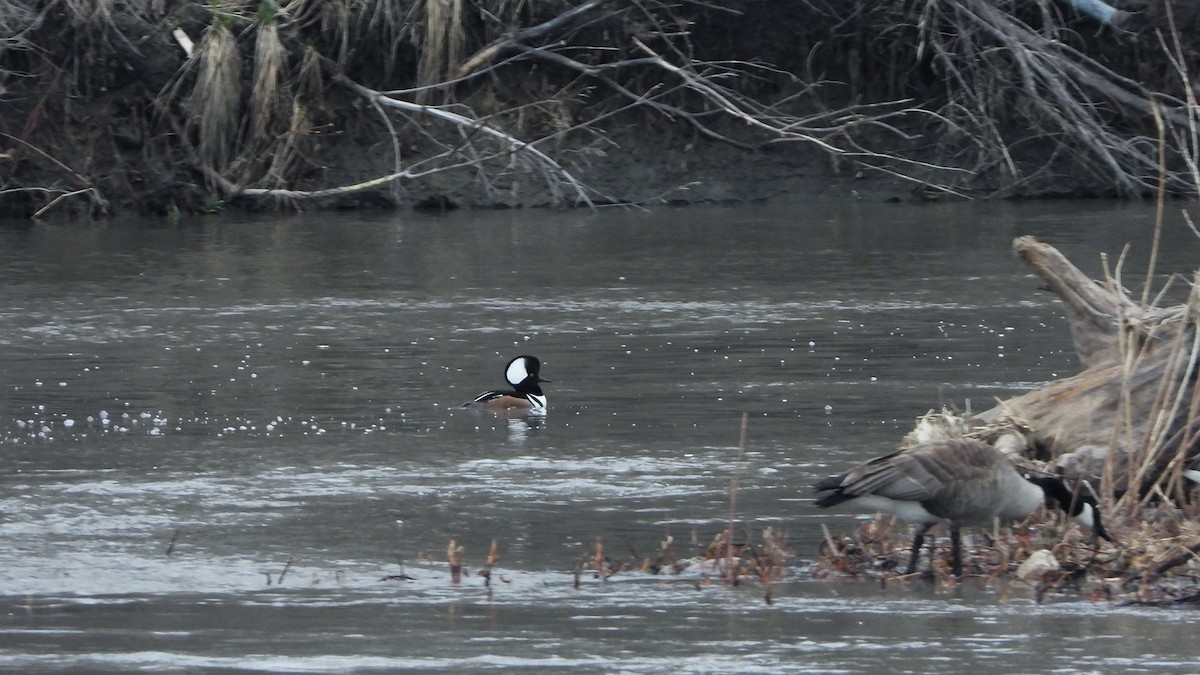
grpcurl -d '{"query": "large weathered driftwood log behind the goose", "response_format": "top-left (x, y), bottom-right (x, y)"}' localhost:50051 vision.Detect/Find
top-left (970, 237), bottom-right (1200, 500)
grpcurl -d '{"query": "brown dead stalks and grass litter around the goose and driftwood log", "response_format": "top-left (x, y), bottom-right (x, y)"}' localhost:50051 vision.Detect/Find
top-left (812, 228), bottom-right (1200, 604)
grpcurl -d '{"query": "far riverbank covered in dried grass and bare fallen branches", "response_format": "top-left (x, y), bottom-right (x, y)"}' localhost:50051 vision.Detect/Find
top-left (7, 0), bottom-right (1200, 215)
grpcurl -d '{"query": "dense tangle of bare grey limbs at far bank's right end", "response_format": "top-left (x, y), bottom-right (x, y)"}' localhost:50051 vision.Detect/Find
top-left (922, 0), bottom-right (1195, 196)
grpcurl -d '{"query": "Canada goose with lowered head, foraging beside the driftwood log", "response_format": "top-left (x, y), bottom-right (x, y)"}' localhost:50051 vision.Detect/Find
top-left (814, 438), bottom-right (1112, 577)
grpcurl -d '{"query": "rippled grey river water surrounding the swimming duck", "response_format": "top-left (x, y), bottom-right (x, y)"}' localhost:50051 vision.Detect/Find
top-left (0, 202), bottom-right (1200, 673)
